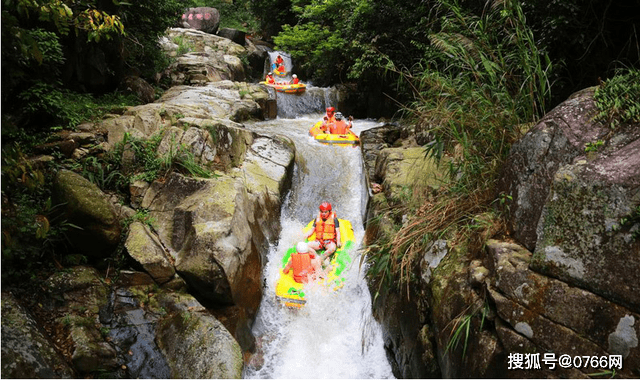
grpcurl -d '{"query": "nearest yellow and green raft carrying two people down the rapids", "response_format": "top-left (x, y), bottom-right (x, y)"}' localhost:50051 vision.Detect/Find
top-left (276, 219), bottom-right (355, 308)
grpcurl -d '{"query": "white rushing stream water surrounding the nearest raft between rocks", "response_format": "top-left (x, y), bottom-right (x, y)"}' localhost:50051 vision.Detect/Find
top-left (244, 86), bottom-right (393, 378)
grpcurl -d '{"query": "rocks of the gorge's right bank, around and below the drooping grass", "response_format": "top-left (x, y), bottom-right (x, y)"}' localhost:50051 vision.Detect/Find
top-left (362, 88), bottom-right (640, 378)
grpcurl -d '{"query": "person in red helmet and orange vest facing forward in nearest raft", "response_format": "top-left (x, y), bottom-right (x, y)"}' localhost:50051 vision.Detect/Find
top-left (305, 202), bottom-right (341, 262)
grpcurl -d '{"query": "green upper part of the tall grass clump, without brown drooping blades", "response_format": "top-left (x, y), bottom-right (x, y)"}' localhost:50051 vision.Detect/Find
top-left (405, 1), bottom-right (551, 191)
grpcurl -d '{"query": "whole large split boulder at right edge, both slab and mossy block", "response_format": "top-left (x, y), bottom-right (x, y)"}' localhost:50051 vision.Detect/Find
top-left (500, 88), bottom-right (640, 309)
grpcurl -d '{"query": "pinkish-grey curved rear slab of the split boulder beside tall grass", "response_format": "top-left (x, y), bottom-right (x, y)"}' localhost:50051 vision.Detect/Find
top-left (499, 88), bottom-right (638, 250)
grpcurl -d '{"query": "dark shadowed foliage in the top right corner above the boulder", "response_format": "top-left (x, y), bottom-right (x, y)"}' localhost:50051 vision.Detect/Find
top-left (522, 0), bottom-right (640, 104)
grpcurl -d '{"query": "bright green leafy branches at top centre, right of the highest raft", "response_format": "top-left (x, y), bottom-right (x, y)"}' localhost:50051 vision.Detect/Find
top-left (274, 0), bottom-right (428, 84)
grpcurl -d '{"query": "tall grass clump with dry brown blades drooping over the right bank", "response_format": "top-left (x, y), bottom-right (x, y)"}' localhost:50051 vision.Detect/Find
top-left (369, 0), bottom-right (551, 292)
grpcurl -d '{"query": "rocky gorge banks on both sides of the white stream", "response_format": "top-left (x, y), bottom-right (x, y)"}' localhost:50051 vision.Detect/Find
top-left (2, 11), bottom-right (640, 378)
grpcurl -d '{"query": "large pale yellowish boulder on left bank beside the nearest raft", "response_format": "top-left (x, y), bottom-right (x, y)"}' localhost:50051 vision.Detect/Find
top-left (136, 128), bottom-right (294, 349)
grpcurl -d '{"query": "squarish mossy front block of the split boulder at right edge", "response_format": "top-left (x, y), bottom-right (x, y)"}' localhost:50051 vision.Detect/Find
top-left (532, 138), bottom-right (640, 310)
